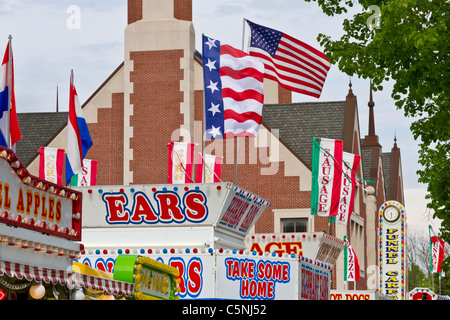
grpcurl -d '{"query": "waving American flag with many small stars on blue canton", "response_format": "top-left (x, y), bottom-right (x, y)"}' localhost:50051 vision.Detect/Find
top-left (247, 20), bottom-right (330, 98)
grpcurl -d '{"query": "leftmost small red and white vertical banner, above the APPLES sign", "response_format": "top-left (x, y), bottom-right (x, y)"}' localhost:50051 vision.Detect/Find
top-left (39, 147), bottom-right (65, 185)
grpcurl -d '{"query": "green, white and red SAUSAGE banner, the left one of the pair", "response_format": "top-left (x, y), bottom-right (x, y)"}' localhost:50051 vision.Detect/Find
top-left (311, 137), bottom-right (343, 217)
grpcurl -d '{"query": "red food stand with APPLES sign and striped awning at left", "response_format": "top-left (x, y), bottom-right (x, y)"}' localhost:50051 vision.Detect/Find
top-left (0, 146), bottom-right (133, 300)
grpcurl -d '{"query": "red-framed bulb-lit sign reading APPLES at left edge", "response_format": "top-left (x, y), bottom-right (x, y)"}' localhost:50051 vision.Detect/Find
top-left (0, 147), bottom-right (81, 241)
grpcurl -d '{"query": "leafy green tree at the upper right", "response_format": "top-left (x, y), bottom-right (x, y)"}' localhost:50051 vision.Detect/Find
top-left (306, 0), bottom-right (450, 272)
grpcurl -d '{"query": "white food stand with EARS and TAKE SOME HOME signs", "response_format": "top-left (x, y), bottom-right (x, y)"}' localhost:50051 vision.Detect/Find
top-left (75, 183), bottom-right (343, 300)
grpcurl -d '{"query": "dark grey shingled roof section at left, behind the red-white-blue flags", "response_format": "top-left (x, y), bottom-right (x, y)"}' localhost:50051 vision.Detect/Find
top-left (16, 112), bottom-right (69, 166)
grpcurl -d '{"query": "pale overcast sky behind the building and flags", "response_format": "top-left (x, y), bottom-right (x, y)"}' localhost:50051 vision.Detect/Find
top-left (0, 0), bottom-right (439, 232)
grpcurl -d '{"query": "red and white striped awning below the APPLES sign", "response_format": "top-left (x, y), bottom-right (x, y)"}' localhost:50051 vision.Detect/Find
top-left (0, 260), bottom-right (134, 297)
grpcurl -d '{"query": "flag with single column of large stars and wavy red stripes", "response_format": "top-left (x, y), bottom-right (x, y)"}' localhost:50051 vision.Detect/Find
top-left (202, 35), bottom-right (264, 140)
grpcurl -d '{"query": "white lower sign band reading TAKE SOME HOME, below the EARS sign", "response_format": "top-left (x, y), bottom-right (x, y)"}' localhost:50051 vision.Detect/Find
top-left (79, 248), bottom-right (331, 300)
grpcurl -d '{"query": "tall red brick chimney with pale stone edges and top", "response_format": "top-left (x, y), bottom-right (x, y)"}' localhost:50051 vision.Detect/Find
top-left (123, 0), bottom-right (195, 184)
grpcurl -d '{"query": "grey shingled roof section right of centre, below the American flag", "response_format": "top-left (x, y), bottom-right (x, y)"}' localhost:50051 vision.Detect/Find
top-left (262, 101), bottom-right (345, 168)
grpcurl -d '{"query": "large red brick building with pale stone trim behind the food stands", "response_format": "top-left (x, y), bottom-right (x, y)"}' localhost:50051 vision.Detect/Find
top-left (17, 0), bottom-right (404, 289)
